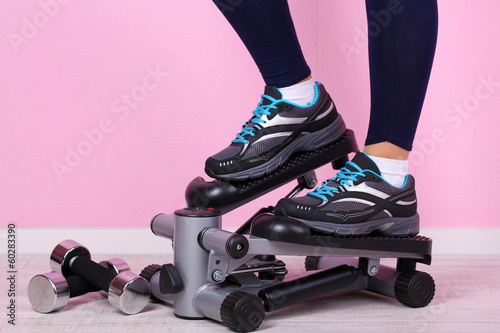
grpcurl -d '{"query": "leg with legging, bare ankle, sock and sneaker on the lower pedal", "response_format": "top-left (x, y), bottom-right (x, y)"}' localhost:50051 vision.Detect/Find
top-left (276, 0), bottom-right (437, 236)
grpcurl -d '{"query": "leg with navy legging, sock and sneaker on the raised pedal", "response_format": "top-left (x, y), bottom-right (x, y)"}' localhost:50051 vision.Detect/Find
top-left (205, 0), bottom-right (345, 180)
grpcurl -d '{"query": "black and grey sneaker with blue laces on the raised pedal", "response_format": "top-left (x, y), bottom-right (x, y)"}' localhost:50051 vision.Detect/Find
top-left (205, 82), bottom-right (345, 180)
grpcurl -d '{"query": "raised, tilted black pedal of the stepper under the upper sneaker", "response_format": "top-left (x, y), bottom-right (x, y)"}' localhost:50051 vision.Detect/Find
top-left (186, 130), bottom-right (358, 213)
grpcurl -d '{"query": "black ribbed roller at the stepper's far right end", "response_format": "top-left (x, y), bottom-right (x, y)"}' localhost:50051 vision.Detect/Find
top-left (394, 271), bottom-right (436, 308)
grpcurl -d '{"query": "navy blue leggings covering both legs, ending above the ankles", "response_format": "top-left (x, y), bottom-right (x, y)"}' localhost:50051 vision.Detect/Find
top-left (213, 0), bottom-right (438, 150)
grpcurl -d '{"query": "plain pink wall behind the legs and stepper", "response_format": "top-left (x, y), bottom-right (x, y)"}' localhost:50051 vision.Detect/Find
top-left (0, 0), bottom-right (500, 227)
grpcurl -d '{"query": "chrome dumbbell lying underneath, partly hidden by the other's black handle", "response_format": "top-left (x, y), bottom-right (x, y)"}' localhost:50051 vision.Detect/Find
top-left (28, 252), bottom-right (130, 313)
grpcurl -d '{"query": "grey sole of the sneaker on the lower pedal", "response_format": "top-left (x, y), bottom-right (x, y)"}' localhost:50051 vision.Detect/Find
top-left (299, 214), bottom-right (420, 237)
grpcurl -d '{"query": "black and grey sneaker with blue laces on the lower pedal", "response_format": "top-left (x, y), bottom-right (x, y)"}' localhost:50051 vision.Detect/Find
top-left (276, 153), bottom-right (419, 236)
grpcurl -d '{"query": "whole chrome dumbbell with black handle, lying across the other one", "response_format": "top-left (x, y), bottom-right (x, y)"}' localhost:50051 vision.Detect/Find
top-left (30, 240), bottom-right (151, 314)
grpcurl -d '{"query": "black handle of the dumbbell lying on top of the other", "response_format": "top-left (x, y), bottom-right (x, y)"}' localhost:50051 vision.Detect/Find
top-left (70, 256), bottom-right (116, 291)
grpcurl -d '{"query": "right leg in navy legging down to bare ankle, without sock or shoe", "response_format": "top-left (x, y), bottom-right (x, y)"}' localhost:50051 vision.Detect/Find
top-left (365, 0), bottom-right (438, 159)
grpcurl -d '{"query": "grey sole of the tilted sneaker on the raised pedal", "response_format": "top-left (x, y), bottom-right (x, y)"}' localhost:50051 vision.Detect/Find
top-left (209, 114), bottom-right (346, 181)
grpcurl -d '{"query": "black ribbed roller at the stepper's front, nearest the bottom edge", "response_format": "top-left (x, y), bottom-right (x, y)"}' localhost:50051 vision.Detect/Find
top-left (220, 291), bottom-right (265, 332)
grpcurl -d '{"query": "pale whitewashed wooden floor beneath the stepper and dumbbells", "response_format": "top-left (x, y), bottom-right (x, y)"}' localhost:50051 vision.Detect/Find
top-left (6, 255), bottom-right (500, 333)
